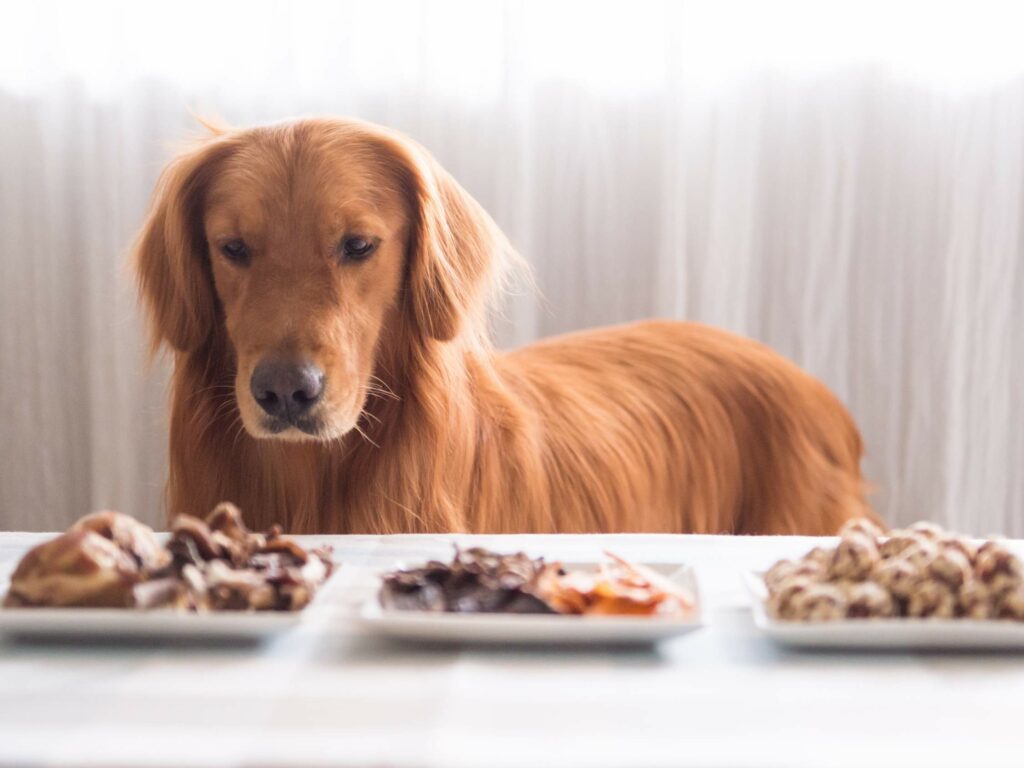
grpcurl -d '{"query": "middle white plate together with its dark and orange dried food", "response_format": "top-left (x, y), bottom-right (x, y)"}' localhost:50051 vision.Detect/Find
top-left (358, 548), bottom-right (702, 645)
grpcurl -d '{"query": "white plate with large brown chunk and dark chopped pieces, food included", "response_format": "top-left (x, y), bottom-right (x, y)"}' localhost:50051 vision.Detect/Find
top-left (0, 503), bottom-right (336, 639)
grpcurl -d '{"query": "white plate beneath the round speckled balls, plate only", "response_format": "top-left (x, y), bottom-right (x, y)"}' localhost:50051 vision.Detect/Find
top-left (743, 571), bottom-right (1024, 651)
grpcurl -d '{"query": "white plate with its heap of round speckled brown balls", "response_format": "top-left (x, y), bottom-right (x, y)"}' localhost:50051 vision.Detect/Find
top-left (745, 520), bottom-right (1024, 650)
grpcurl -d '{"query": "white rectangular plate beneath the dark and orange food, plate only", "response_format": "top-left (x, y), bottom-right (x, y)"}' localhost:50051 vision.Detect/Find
top-left (356, 562), bottom-right (703, 645)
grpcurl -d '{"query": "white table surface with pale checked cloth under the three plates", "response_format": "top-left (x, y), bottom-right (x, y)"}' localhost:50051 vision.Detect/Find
top-left (0, 534), bottom-right (1024, 768)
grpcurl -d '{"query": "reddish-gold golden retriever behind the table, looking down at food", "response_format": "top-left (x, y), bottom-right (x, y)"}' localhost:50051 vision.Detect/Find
top-left (135, 119), bottom-right (872, 534)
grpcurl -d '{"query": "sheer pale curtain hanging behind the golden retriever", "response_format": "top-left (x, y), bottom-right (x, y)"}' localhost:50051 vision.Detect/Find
top-left (0, 0), bottom-right (1024, 536)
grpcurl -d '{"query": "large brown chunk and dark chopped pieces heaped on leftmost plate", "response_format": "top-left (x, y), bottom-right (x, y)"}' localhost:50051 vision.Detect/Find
top-left (4, 503), bottom-right (333, 611)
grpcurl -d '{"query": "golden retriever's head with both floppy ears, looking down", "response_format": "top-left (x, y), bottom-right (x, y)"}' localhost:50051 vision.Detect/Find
top-left (135, 120), bottom-right (506, 440)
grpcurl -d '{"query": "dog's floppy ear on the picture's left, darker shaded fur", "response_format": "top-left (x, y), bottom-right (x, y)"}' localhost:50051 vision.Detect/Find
top-left (133, 135), bottom-right (232, 351)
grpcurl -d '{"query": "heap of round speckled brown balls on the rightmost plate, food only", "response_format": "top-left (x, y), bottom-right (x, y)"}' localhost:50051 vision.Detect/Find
top-left (764, 520), bottom-right (1024, 621)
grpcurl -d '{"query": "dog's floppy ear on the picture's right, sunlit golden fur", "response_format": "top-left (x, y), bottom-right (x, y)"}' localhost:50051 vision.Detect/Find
top-left (392, 139), bottom-right (511, 341)
